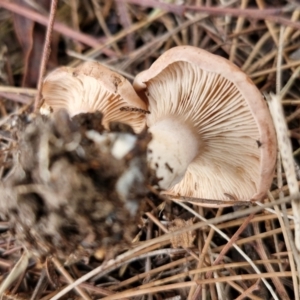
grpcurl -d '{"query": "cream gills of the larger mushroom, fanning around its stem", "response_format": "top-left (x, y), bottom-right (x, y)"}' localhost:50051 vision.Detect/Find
top-left (146, 62), bottom-right (261, 200)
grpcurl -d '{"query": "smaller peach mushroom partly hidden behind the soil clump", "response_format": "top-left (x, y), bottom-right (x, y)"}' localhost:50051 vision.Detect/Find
top-left (41, 61), bottom-right (146, 132)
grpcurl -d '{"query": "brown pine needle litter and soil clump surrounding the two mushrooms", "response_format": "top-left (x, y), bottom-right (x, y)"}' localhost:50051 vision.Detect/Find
top-left (0, 0), bottom-right (300, 299)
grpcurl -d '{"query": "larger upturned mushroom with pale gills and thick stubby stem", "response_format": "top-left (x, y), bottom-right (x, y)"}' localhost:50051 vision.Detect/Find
top-left (133, 46), bottom-right (276, 206)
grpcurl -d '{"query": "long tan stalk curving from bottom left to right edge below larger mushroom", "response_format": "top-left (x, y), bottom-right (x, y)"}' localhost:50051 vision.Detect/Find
top-left (48, 196), bottom-right (294, 300)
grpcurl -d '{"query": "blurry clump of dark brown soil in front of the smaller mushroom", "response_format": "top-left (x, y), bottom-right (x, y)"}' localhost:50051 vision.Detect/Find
top-left (0, 111), bottom-right (149, 261)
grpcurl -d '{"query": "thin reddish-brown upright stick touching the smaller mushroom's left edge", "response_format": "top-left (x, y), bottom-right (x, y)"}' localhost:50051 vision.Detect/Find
top-left (34, 0), bottom-right (58, 112)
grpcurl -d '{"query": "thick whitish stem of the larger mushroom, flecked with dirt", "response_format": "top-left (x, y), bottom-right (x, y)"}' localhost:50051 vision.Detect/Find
top-left (147, 116), bottom-right (199, 189)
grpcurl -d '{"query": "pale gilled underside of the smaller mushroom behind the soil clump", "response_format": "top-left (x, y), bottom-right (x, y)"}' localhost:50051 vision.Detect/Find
top-left (42, 68), bottom-right (145, 131)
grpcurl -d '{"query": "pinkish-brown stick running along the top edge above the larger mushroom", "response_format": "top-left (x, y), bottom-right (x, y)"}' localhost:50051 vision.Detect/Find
top-left (117, 0), bottom-right (300, 29)
